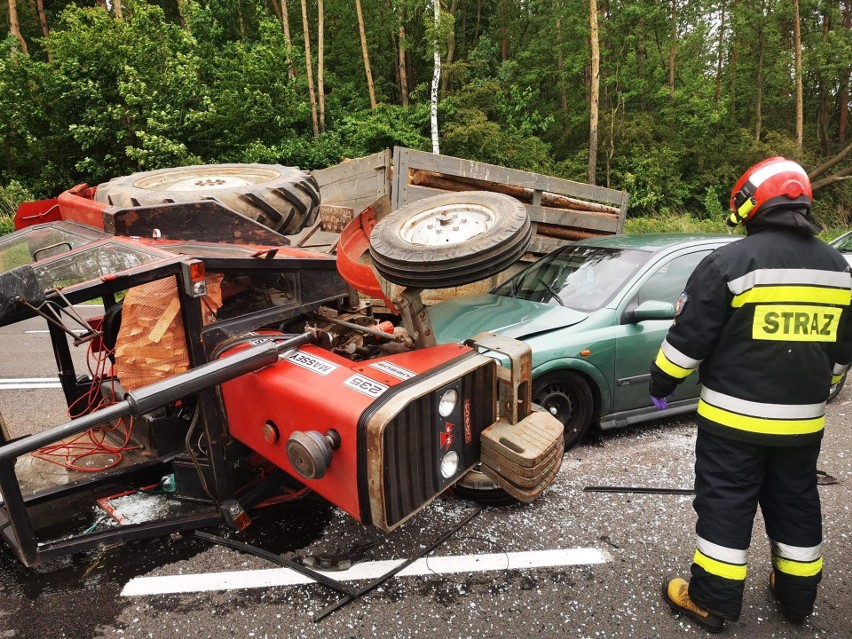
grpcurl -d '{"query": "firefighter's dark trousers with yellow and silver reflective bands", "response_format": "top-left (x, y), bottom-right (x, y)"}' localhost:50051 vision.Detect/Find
top-left (689, 428), bottom-right (822, 621)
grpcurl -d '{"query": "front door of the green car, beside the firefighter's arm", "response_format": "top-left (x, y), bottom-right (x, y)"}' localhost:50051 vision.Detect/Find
top-left (613, 248), bottom-right (712, 412)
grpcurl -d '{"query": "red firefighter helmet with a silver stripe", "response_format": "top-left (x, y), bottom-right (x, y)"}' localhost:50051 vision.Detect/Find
top-left (725, 157), bottom-right (813, 226)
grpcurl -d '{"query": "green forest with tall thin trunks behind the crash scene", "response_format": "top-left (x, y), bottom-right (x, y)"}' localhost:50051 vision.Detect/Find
top-left (0, 0), bottom-right (852, 234)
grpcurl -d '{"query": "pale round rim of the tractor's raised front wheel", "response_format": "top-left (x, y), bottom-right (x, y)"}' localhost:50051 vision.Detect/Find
top-left (400, 204), bottom-right (497, 246)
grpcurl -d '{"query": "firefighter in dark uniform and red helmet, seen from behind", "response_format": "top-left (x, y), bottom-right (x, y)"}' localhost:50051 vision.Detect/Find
top-left (650, 157), bottom-right (852, 632)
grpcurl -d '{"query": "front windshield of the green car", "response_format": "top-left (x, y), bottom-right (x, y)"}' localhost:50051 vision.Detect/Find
top-left (491, 245), bottom-right (651, 311)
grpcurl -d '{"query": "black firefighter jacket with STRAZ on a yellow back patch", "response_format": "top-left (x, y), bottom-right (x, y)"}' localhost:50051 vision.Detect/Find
top-left (651, 214), bottom-right (852, 445)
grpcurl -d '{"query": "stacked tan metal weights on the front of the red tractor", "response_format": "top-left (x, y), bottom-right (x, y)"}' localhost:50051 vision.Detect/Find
top-left (480, 412), bottom-right (565, 503)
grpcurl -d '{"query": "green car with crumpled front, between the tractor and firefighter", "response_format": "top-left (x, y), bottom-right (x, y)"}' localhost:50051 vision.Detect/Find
top-left (430, 234), bottom-right (737, 448)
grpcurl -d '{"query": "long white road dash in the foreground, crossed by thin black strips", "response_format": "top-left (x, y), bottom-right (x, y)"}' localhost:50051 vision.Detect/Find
top-left (121, 548), bottom-right (612, 597)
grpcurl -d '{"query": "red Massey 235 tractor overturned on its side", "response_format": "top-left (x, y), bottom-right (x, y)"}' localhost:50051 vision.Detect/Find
top-left (0, 162), bottom-right (562, 565)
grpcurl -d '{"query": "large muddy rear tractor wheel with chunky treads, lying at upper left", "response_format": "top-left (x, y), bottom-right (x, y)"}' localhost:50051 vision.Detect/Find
top-left (95, 164), bottom-right (320, 235)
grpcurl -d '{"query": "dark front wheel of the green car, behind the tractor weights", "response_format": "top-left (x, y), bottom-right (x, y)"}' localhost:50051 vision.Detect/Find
top-left (533, 371), bottom-right (594, 450)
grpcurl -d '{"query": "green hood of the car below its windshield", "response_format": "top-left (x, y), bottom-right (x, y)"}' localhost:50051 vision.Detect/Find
top-left (429, 295), bottom-right (588, 342)
